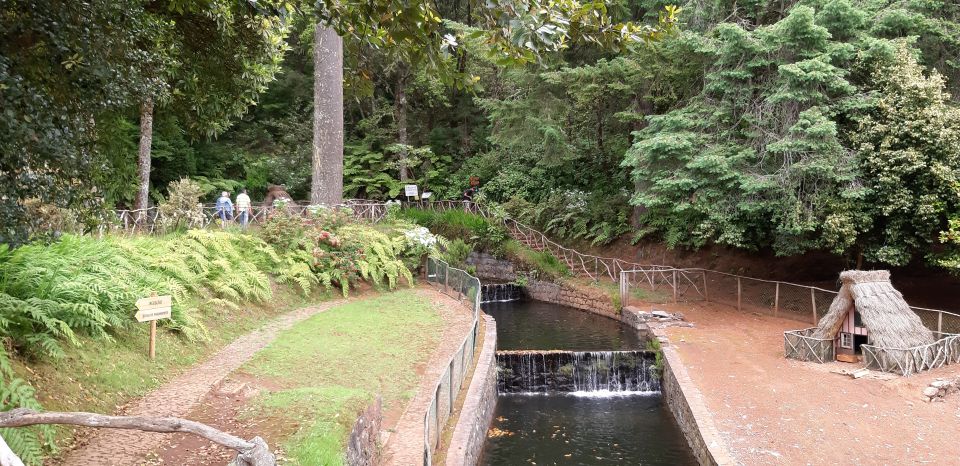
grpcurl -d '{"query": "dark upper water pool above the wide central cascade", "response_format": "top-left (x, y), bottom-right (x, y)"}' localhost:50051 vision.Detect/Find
top-left (483, 301), bottom-right (646, 351)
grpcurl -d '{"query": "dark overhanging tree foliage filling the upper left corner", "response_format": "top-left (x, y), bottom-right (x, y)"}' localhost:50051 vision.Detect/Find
top-left (0, 0), bottom-right (287, 244)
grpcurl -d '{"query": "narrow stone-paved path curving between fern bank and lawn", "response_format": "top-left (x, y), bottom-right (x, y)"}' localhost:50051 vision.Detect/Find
top-left (59, 298), bottom-right (348, 466)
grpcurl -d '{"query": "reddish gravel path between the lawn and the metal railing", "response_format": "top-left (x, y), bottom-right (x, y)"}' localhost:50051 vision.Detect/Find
top-left (381, 288), bottom-right (473, 466)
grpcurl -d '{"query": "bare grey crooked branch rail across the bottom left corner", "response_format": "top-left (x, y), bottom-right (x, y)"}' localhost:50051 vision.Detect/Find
top-left (0, 408), bottom-right (276, 466)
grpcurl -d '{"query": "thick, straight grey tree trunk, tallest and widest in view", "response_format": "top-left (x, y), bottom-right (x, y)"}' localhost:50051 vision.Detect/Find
top-left (310, 22), bottom-right (343, 205)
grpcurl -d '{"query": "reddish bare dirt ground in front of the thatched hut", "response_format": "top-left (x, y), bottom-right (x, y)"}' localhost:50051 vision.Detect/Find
top-left (657, 303), bottom-right (960, 465)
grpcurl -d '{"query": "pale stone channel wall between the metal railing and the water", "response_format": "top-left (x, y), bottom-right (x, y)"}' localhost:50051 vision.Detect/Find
top-left (446, 314), bottom-right (497, 466)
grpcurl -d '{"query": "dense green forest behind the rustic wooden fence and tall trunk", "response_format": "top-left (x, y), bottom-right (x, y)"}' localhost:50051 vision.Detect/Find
top-left (0, 0), bottom-right (960, 269)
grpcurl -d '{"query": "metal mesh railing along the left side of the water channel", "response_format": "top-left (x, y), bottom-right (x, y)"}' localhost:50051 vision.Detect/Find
top-left (423, 258), bottom-right (481, 466)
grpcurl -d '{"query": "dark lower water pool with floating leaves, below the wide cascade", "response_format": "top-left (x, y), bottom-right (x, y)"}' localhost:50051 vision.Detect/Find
top-left (480, 395), bottom-right (697, 466)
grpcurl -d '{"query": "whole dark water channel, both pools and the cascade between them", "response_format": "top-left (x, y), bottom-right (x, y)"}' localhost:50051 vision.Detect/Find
top-left (480, 301), bottom-right (697, 465)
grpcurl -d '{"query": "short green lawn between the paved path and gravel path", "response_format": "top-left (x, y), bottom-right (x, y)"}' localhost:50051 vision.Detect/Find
top-left (240, 290), bottom-right (443, 465)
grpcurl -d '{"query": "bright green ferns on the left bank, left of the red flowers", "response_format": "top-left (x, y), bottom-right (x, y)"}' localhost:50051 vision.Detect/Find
top-left (0, 230), bottom-right (279, 462)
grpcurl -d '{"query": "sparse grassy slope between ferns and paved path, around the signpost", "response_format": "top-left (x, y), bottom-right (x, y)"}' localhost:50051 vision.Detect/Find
top-left (13, 286), bottom-right (330, 454)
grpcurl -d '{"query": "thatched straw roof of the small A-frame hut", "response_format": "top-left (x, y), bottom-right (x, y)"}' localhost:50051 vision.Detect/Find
top-left (813, 270), bottom-right (934, 348)
